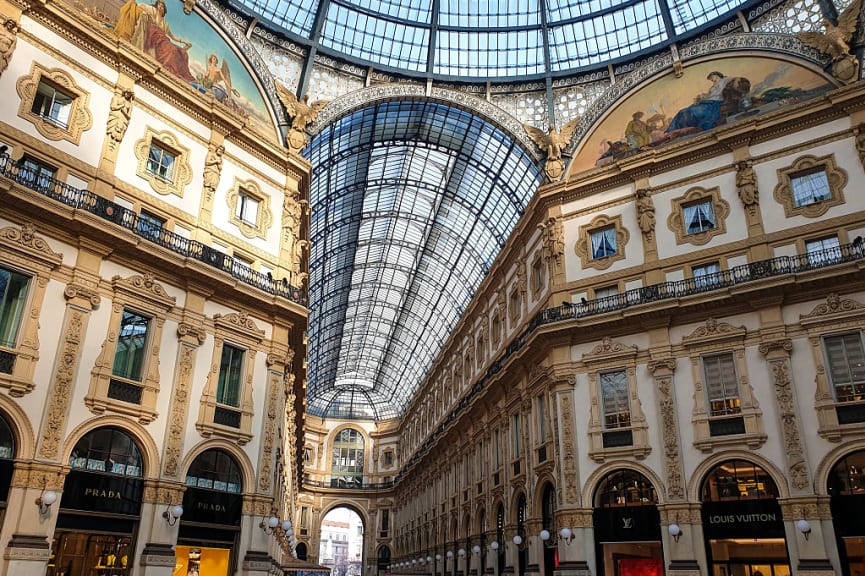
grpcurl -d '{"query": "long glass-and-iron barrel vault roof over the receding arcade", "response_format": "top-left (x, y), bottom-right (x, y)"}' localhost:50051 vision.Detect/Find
top-left (305, 101), bottom-right (540, 420)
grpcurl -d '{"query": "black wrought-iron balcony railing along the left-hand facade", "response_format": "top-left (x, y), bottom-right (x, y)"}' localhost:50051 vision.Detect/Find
top-left (0, 155), bottom-right (309, 306)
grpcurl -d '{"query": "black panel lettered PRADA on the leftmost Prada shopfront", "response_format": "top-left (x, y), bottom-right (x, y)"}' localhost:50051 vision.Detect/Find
top-left (60, 470), bottom-right (144, 516)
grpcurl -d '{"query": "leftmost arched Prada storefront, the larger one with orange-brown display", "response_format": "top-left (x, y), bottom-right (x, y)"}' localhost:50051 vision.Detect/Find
top-left (46, 427), bottom-right (144, 576)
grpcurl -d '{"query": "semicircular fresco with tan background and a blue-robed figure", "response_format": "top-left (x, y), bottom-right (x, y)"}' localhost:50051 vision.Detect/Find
top-left (570, 57), bottom-right (834, 174)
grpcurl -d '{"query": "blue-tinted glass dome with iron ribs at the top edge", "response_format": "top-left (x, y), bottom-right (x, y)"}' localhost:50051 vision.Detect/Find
top-left (229, 0), bottom-right (754, 80)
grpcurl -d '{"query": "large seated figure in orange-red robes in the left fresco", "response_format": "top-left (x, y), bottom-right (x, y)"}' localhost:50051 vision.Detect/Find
top-left (114, 0), bottom-right (195, 82)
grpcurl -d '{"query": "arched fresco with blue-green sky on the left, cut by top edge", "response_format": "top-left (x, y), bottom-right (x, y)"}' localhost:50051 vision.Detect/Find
top-left (74, 0), bottom-right (275, 133)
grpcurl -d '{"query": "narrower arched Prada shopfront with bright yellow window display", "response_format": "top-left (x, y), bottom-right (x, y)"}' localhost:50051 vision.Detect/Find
top-left (176, 448), bottom-right (243, 576)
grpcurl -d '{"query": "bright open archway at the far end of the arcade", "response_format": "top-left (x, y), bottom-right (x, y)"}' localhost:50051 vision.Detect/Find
top-left (318, 507), bottom-right (366, 576)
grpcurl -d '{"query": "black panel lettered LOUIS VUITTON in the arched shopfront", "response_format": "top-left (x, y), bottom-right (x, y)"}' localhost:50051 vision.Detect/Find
top-left (703, 498), bottom-right (784, 538)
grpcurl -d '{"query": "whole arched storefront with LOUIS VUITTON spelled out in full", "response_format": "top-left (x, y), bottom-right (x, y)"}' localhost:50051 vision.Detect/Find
top-left (701, 460), bottom-right (790, 576)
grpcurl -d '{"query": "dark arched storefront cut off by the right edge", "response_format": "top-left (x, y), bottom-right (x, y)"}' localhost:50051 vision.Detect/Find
top-left (827, 452), bottom-right (865, 576)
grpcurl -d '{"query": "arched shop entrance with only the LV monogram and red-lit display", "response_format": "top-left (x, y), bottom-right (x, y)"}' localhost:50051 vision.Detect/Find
top-left (593, 469), bottom-right (664, 576)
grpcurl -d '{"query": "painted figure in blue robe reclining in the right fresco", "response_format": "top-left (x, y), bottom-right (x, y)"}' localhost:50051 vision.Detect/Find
top-left (667, 71), bottom-right (751, 136)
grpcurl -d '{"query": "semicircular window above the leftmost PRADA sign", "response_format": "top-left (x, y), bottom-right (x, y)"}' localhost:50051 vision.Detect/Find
top-left (69, 427), bottom-right (144, 477)
